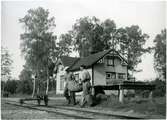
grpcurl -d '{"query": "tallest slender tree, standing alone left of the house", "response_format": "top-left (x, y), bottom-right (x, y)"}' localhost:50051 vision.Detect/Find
top-left (19, 7), bottom-right (57, 94)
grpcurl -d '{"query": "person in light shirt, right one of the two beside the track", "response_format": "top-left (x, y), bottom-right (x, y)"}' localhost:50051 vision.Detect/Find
top-left (80, 65), bottom-right (91, 107)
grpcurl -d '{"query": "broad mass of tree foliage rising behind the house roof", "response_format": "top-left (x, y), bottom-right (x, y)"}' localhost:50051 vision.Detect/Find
top-left (63, 17), bottom-right (151, 72)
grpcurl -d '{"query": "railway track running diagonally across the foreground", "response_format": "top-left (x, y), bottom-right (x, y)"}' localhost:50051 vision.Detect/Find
top-left (6, 101), bottom-right (143, 119)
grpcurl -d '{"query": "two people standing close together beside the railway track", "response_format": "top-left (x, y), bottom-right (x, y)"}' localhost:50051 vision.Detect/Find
top-left (64, 65), bottom-right (91, 107)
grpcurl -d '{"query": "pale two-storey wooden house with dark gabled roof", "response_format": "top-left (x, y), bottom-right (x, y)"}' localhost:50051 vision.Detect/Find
top-left (56, 49), bottom-right (128, 94)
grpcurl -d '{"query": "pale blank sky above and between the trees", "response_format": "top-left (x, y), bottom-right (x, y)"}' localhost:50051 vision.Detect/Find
top-left (1, 0), bottom-right (166, 80)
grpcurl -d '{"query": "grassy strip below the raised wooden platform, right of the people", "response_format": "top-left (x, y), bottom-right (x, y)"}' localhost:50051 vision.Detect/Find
top-left (97, 96), bottom-right (166, 116)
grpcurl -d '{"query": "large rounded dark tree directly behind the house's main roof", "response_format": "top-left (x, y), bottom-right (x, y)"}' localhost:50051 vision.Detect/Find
top-left (72, 17), bottom-right (115, 57)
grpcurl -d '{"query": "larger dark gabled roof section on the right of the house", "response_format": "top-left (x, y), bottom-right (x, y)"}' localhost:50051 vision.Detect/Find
top-left (69, 49), bottom-right (127, 71)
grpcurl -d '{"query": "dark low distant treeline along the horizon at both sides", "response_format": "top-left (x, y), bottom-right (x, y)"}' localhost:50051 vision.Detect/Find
top-left (1, 78), bottom-right (166, 97)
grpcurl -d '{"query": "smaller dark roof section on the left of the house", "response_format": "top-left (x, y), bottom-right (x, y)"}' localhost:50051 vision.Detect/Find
top-left (60, 56), bottom-right (78, 66)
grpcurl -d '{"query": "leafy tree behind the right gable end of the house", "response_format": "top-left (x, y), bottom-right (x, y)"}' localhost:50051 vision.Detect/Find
top-left (117, 25), bottom-right (151, 74)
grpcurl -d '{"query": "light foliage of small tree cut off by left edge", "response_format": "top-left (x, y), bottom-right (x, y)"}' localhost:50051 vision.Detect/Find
top-left (1, 46), bottom-right (13, 80)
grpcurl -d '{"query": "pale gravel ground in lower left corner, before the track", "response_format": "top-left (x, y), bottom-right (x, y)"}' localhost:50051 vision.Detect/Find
top-left (1, 99), bottom-right (72, 120)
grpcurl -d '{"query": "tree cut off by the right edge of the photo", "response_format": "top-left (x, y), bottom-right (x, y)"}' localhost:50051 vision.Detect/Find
top-left (154, 29), bottom-right (166, 80)
